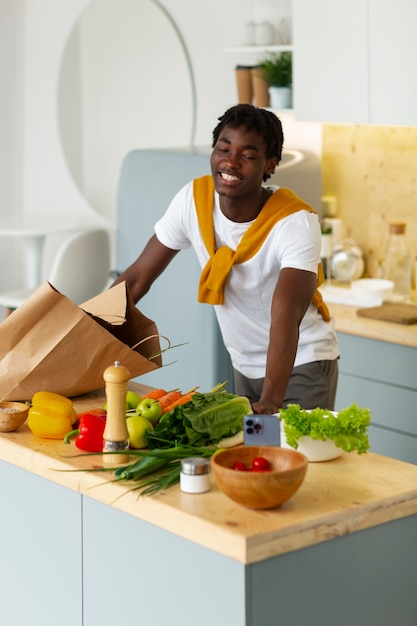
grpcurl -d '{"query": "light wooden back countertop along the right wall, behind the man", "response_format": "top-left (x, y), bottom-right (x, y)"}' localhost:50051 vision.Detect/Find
top-left (328, 303), bottom-right (417, 348)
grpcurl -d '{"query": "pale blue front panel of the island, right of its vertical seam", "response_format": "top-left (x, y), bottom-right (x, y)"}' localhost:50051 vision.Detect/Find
top-left (81, 494), bottom-right (244, 626)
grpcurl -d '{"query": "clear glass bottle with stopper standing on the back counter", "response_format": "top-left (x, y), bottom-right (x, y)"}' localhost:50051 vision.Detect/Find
top-left (384, 222), bottom-right (411, 300)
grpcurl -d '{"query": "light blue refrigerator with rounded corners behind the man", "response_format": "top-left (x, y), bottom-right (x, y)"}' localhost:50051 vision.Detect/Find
top-left (116, 147), bottom-right (321, 392)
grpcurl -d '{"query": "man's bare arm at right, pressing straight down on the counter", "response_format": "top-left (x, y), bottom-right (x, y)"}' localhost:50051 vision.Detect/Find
top-left (253, 268), bottom-right (317, 414)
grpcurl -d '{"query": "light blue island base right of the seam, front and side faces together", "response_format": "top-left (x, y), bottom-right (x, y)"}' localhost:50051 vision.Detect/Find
top-left (83, 498), bottom-right (417, 626)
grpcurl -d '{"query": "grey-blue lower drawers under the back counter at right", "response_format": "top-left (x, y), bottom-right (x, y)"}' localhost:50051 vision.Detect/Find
top-left (336, 333), bottom-right (417, 464)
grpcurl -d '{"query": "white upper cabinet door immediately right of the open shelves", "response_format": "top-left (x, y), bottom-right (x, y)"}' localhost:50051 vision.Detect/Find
top-left (292, 0), bottom-right (368, 123)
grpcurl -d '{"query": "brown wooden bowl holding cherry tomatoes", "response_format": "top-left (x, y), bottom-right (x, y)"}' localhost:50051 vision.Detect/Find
top-left (211, 446), bottom-right (308, 509)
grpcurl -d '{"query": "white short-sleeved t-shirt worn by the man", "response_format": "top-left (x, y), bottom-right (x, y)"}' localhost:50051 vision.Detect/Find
top-left (155, 182), bottom-right (339, 379)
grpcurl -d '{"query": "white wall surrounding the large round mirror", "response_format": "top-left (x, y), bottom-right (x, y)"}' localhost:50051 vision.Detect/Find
top-left (0, 0), bottom-right (320, 289)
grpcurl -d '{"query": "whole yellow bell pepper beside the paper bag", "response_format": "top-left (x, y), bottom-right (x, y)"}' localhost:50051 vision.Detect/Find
top-left (28, 391), bottom-right (77, 439)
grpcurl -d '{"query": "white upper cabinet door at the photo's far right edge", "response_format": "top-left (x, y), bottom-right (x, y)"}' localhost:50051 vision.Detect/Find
top-left (369, 0), bottom-right (417, 126)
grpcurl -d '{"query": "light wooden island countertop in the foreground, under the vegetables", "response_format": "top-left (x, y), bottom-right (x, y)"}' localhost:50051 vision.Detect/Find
top-left (0, 383), bottom-right (417, 563)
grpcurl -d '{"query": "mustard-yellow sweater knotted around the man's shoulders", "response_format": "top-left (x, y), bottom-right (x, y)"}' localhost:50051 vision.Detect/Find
top-left (193, 176), bottom-right (330, 322)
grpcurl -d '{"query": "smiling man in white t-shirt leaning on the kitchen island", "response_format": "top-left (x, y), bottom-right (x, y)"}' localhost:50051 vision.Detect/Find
top-left (116, 105), bottom-right (339, 414)
